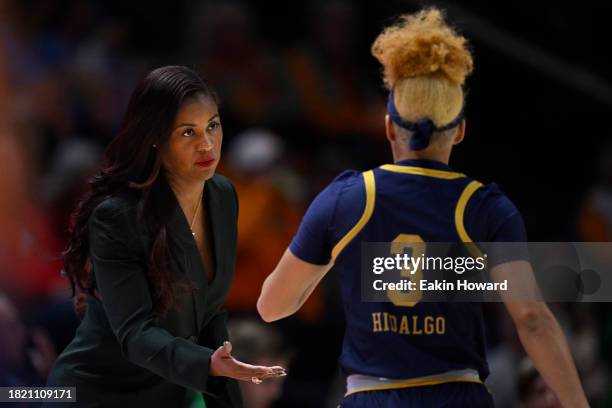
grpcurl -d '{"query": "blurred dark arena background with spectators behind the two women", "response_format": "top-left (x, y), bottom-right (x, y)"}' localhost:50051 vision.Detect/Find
top-left (0, 0), bottom-right (612, 408)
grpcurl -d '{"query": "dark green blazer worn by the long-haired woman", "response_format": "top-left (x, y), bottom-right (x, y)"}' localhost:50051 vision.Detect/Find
top-left (47, 175), bottom-right (242, 408)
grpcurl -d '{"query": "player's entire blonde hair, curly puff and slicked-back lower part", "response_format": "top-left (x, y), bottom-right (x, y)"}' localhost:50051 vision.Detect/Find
top-left (372, 8), bottom-right (473, 126)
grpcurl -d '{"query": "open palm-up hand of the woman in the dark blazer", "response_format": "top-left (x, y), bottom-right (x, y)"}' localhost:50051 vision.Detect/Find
top-left (208, 341), bottom-right (287, 384)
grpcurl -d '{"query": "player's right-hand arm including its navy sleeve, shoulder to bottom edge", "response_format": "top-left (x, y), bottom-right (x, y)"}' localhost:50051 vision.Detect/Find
top-left (471, 186), bottom-right (588, 408)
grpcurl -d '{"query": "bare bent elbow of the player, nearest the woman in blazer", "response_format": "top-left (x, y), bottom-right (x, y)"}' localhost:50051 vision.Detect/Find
top-left (257, 249), bottom-right (333, 322)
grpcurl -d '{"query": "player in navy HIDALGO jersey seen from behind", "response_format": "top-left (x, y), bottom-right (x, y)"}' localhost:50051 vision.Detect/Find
top-left (257, 9), bottom-right (587, 407)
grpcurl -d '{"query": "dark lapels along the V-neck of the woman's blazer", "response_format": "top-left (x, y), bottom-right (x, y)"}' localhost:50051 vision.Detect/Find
top-left (168, 178), bottom-right (224, 333)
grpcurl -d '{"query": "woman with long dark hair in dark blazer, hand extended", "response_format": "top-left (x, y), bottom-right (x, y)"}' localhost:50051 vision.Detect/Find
top-left (48, 66), bottom-right (284, 407)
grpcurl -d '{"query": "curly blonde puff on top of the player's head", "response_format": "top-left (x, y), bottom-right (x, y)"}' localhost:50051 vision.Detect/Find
top-left (372, 8), bottom-right (473, 88)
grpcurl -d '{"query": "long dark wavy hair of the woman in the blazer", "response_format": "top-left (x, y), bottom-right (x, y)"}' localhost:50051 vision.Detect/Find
top-left (63, 66), bottom-right (218, 317)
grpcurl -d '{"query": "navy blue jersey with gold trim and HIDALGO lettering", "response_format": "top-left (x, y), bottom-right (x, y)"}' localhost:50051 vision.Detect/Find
top-left (290, 160), bottom-right (526, 381)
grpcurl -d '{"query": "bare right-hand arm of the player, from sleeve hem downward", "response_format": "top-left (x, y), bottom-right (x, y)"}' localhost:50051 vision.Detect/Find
top-left (491, 260), bottom-right (589, 408)
